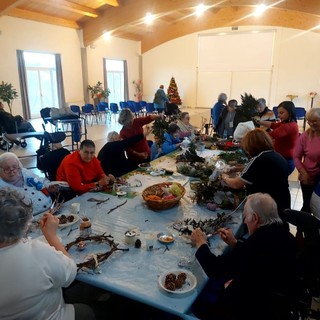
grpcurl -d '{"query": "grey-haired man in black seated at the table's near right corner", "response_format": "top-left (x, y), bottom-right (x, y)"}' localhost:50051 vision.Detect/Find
top-left (191, 193), bottom-right (296, 320)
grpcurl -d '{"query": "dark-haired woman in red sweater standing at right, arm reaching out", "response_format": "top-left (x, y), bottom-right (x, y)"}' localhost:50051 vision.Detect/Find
top-left (258, 101), bottom-right (299, 175)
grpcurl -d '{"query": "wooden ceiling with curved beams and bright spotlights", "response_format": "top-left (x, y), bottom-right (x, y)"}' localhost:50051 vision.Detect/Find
top-left (0, 0), bottom-right (320, 53)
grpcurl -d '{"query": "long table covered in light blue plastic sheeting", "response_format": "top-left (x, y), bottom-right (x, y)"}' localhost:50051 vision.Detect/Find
top-left (31, 152), bottom-right (241, 319)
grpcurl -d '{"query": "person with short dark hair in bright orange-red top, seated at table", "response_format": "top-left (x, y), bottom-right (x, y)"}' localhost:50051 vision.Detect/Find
top-left (57, 140), bottom-right (115, 194)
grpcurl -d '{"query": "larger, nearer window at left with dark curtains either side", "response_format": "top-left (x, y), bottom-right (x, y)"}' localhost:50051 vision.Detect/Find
top-left (23, 52), bottom-right (59, 118)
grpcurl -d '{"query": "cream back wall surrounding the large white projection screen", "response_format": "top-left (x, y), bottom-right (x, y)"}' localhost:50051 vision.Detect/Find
top-left (142, 27), bottom-right (320, 109)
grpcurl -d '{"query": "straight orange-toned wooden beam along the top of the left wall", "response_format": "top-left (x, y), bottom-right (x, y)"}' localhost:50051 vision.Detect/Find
top-left (9, 8), bottom-right (80, 29)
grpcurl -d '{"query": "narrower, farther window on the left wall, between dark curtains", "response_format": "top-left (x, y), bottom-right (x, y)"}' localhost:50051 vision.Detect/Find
top-left (105, 60), bottom-right (125, 104)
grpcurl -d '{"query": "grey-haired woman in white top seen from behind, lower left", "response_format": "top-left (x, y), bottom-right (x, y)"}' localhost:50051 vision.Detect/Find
top-left (0, 189), bottom-right (95, 320)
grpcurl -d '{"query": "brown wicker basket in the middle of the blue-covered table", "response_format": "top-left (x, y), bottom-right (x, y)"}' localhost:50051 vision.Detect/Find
top-left (142, 182), bottom-right (186, 210)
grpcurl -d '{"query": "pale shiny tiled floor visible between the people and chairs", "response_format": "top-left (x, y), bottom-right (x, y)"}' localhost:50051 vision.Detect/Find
top-left (0, 108), bottom-right (302, 210)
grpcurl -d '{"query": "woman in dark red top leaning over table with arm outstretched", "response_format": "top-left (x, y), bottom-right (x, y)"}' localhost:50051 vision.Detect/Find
top-left (118, 108), bottom-right (161, 164)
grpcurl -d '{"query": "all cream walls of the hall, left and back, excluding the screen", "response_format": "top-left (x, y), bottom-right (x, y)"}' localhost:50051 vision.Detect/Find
top-left (0, 16), bottom-right (320, 114)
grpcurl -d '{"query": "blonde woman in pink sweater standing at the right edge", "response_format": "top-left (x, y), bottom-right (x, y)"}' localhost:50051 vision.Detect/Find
top-left (293, 108), bottom-right (320, 212)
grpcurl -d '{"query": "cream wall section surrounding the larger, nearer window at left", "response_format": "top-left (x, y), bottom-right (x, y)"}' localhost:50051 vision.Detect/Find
top-left (0, 16), bottom-right (83, 114)
